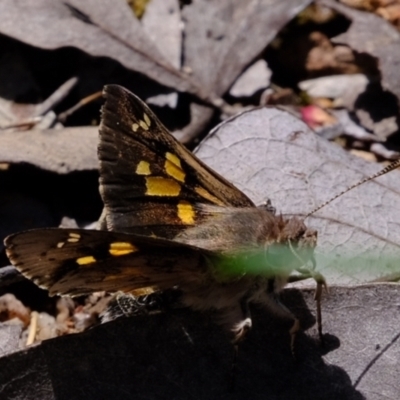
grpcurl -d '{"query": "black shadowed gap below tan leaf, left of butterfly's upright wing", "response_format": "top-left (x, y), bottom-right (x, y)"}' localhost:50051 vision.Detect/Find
top-left (0, 164), bottom-right (103, 234)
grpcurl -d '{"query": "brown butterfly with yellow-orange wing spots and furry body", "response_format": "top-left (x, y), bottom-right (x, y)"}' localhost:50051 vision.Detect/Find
top-left (5, 85), bottom-right (324, 344)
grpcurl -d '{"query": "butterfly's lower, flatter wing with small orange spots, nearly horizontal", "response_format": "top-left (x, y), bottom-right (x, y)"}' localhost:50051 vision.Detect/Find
top-left (4, 228), bottom-right (207, 296)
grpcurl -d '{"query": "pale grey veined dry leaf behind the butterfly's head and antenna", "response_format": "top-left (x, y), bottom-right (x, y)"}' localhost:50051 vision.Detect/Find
top-left (197, 108), bottom-right (400, 285)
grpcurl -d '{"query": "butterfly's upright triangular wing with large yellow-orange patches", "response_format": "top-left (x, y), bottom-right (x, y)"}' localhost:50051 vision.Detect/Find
top-left (98, 85), bottom-right (254, 238)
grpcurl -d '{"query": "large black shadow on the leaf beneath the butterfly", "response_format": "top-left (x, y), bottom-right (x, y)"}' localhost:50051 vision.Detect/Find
top-left (0, 290), bottom-right (364, 400)
